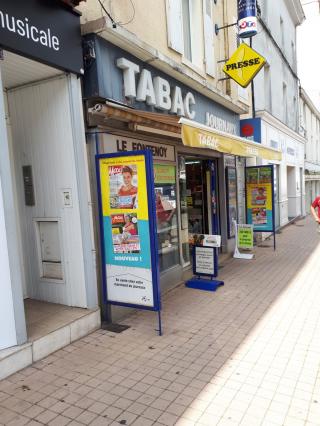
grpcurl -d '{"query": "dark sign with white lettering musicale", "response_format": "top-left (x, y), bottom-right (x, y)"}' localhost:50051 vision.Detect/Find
top-left (0, 0), bottom-right (83, 74)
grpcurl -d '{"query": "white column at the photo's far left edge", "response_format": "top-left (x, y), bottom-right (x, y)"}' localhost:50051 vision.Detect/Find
top-left (0, 63), bottom-right (27, 350)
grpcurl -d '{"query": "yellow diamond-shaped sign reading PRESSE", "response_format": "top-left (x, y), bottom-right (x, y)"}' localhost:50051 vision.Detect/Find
top-left (223, 43), bottom-right (266, 87)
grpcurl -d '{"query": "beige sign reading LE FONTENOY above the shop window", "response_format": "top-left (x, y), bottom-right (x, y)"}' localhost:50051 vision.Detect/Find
top-left (102, 134), bottom-right (176, 161)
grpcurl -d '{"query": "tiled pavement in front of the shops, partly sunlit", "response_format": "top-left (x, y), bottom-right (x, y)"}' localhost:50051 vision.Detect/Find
top-left (0, 219), bottom-right (320, 426)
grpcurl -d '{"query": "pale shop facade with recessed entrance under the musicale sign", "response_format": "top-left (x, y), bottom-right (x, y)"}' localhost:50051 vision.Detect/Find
top-left (0, 0), bottom-right (100, 377)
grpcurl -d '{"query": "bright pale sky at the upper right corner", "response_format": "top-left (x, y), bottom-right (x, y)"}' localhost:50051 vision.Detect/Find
top-left (297, 0), bottom-right (320, 109)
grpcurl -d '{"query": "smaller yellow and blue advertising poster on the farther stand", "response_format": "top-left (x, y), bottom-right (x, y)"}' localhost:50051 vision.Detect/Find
top-left (246, 166), bottom-right (274, 232)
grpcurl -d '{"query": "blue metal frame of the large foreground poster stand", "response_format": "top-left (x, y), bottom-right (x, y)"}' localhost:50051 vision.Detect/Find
top-left (95, 150), bottom-right (162, 336)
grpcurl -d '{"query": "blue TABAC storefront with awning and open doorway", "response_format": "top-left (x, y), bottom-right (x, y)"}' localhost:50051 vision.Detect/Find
top-left (84, 35), bottom-right (280, 318)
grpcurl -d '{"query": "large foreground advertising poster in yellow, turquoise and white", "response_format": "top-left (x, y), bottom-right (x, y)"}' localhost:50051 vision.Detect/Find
top-left (97, 153), bottom-right (158, 310)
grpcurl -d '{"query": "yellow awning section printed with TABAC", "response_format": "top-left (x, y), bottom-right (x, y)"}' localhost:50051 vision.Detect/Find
top-left (181, 124), bottom-right (282, 161)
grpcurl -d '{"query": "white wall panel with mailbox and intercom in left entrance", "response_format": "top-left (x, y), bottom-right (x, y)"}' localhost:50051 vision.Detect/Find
top-left (8, 76), bottom-right (86, 307)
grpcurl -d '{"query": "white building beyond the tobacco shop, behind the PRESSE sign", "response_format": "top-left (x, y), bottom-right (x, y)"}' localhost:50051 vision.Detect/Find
top-left (249, 0), bottom-right (305, 226)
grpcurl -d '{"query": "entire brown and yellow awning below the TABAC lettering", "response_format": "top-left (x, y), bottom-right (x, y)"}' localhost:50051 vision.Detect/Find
top-left (89, 104), bottom-right (282, 161)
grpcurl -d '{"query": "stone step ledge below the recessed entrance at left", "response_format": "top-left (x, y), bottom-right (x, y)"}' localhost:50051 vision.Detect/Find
top-left (0, 300), bottom-right (101, 380)
